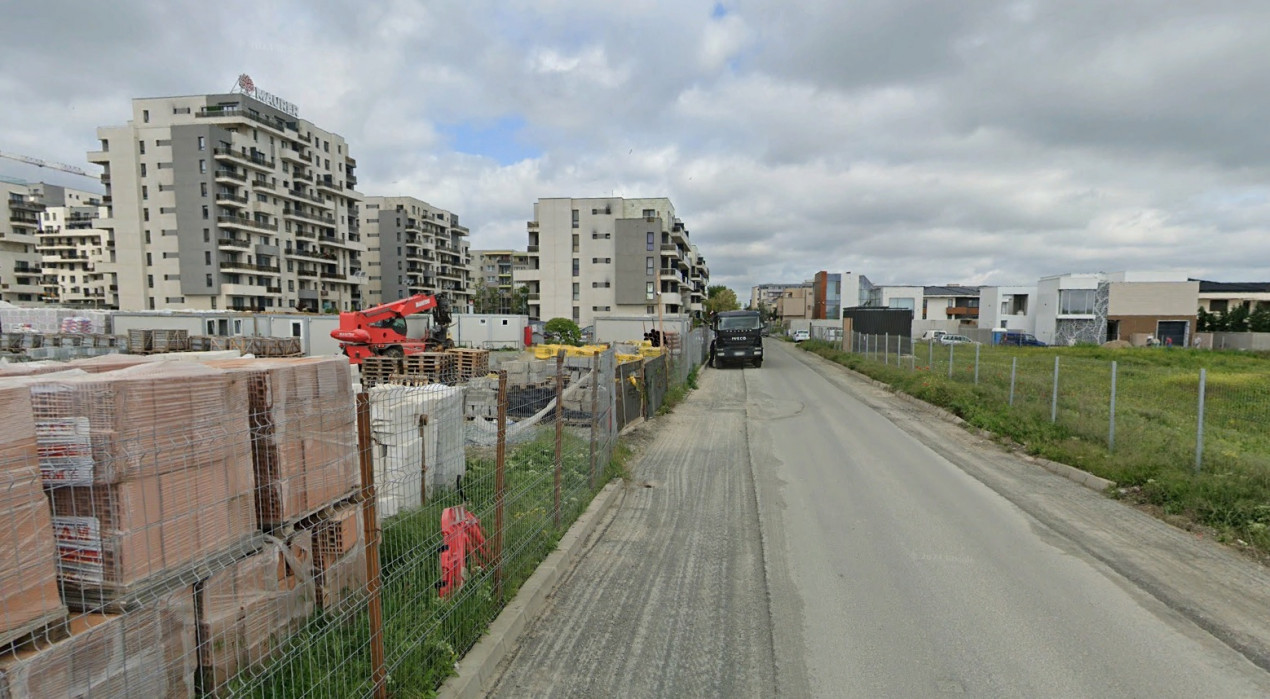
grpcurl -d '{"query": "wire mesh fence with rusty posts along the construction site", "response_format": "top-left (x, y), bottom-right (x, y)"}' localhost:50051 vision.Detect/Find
top-left (0, 336), bottom-right (675, 699)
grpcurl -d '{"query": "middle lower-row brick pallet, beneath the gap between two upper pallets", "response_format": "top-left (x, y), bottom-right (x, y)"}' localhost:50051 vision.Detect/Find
top-left (198, 530), bottom-right (316, 695)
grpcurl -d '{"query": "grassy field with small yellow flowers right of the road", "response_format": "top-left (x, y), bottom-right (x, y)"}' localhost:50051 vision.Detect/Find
top-left (801, 341), bottom-right (1270, 552)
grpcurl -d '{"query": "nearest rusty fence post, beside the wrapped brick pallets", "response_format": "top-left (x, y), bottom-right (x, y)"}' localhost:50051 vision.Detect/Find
top-left (357, 391), bottom-right (389, 699)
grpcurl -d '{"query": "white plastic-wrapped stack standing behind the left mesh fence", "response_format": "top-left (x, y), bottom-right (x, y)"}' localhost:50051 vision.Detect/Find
top-left (370, 384), bottom-right (466, 519)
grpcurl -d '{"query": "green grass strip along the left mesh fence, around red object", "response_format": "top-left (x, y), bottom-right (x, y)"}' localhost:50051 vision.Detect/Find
top-left (230, 428), bottom-right (630, 698)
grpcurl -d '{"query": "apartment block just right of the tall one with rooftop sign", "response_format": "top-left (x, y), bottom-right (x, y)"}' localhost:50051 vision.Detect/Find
top-left (361, 197), bottom-right (472, 311)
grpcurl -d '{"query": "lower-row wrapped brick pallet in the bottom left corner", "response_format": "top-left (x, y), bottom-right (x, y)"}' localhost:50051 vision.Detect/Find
top-left (0, 586), bottom-right (198, 699)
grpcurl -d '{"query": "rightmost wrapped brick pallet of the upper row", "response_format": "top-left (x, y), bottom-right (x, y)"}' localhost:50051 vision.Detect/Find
top-left (207, 357), bottom-right (361, 531)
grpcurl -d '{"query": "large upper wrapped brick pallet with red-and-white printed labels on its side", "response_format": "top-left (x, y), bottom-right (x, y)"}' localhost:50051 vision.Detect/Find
top-left (25, 362), bottom-right (258, 609)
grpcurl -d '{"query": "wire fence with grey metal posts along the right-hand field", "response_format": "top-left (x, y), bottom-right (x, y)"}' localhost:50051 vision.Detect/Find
top-left (843, 333), bottom-right (1270, 474)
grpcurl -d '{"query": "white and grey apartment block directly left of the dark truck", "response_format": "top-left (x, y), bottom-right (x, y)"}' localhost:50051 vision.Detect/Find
top-left (516, 197), bottom-right (710, 325)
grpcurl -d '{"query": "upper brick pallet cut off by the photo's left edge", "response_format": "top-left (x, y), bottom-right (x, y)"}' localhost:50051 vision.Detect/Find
top-left (0, 385), bottom-right (66, 646)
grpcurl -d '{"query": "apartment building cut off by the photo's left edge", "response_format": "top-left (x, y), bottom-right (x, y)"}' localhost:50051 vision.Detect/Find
top-left (0, 178), bottom-right (44, 306)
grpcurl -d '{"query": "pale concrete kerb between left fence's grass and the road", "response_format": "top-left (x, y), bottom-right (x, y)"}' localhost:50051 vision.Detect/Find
top-left (437, 479), bottom-right (625, 699)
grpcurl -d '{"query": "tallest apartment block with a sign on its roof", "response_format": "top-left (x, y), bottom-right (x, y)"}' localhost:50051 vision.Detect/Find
top-left (89, 88), bottom-right (366, 311)
